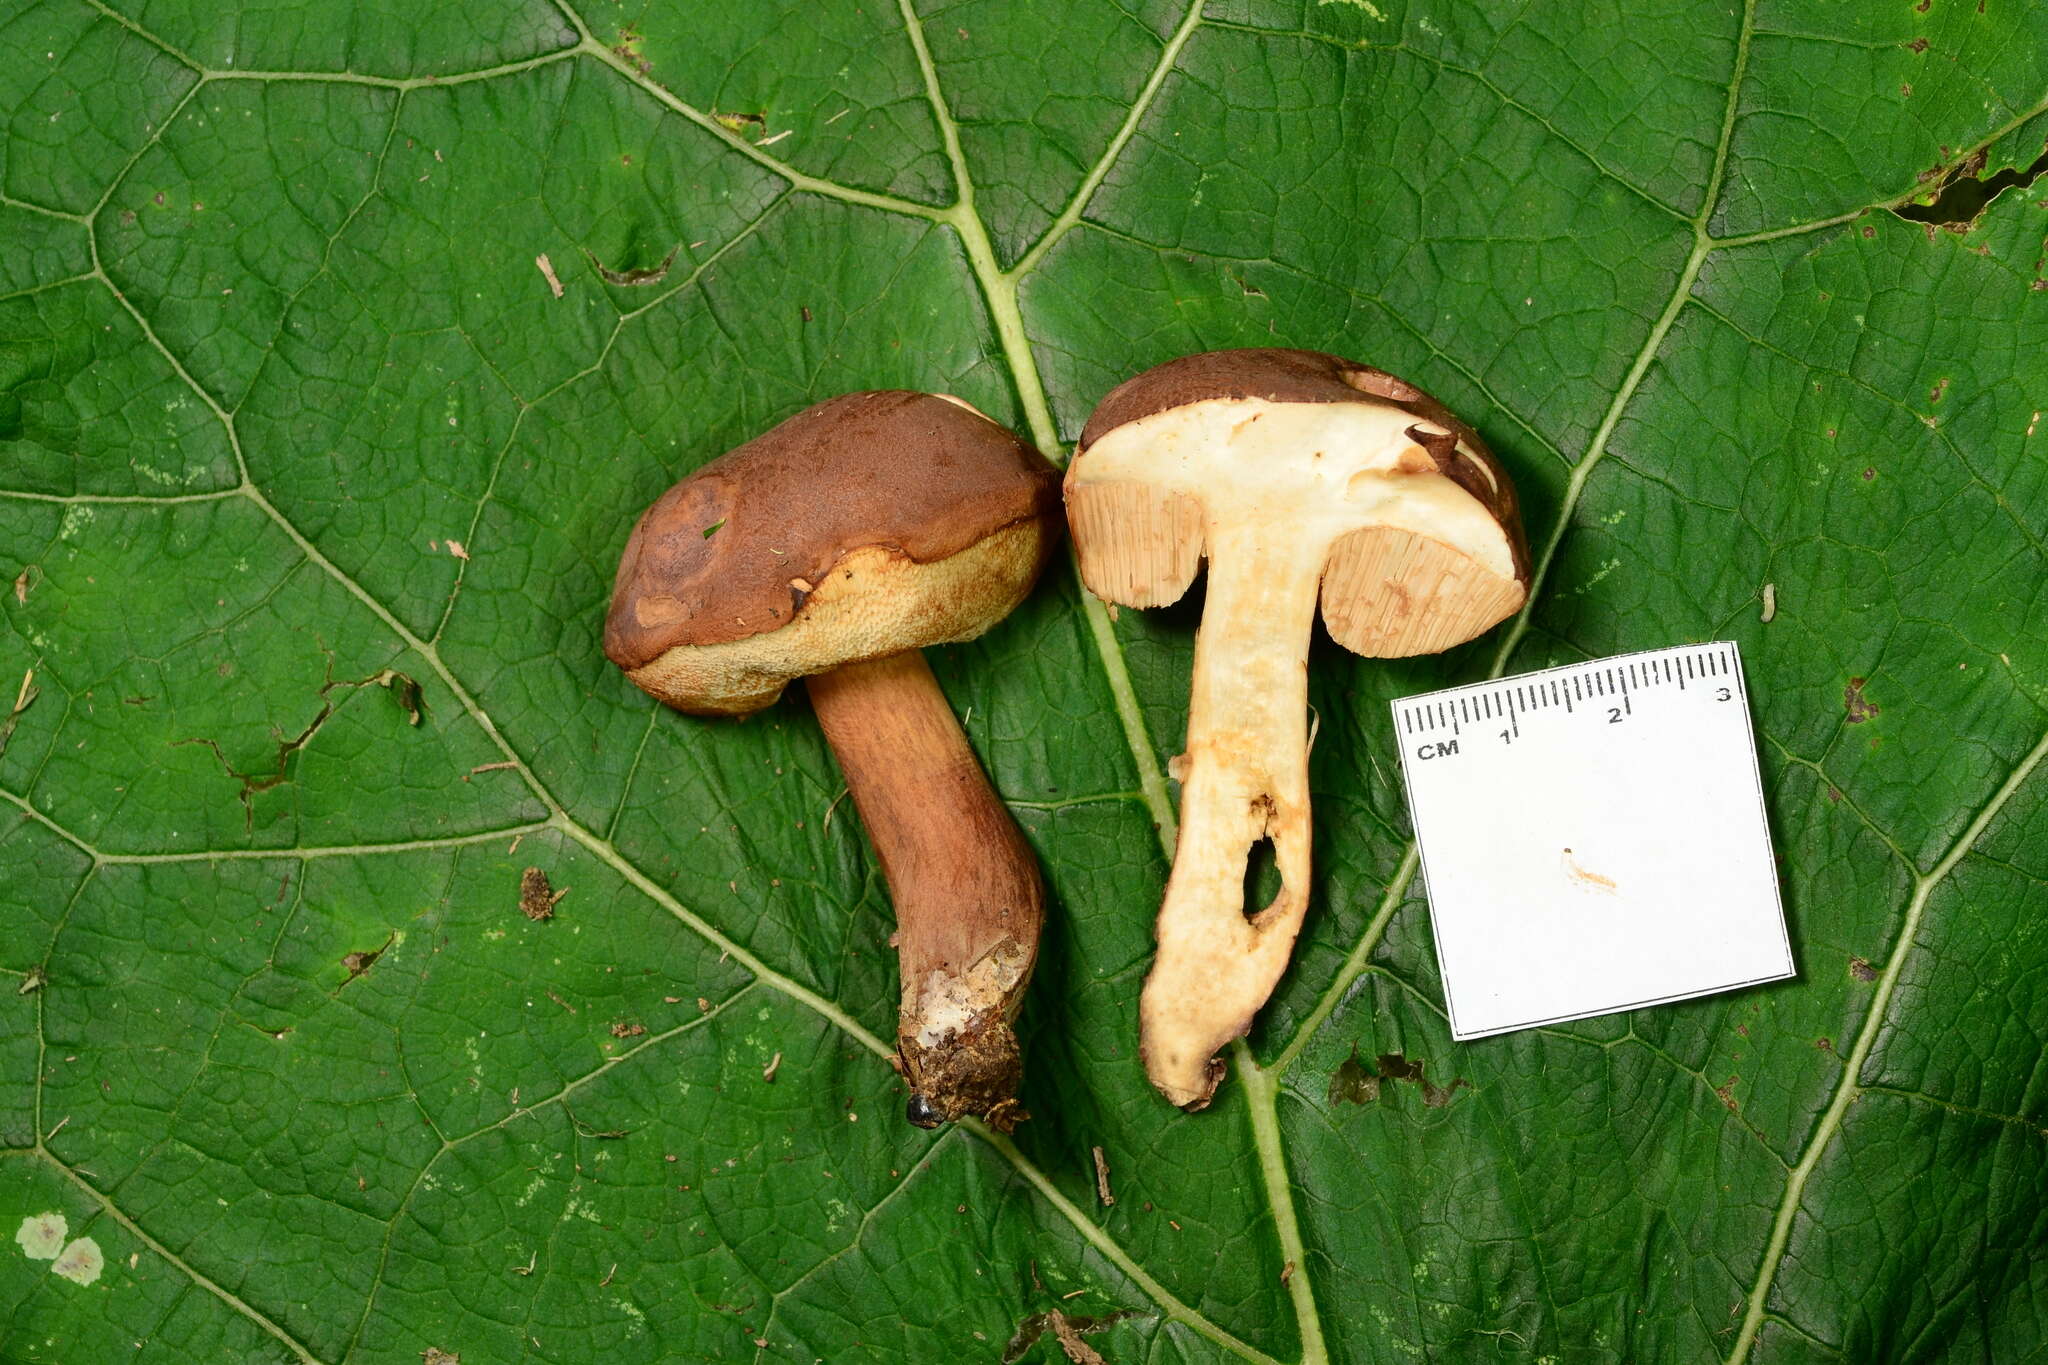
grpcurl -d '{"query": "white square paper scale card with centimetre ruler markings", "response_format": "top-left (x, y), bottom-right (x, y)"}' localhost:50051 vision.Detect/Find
top-left (1393, 643), bottom-right (1792, 1040)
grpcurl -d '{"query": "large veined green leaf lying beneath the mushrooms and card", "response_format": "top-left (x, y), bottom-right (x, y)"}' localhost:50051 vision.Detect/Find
top-left (0, 0), bottom-right (2048, 1363)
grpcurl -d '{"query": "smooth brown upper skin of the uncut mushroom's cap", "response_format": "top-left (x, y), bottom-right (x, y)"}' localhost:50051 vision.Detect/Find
top-left (604, 389), bottom-right (1059, 669)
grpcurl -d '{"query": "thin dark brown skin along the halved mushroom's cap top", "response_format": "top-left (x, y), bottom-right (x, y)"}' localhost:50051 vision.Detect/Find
top-left (1075, 346), bottom-right (1530, 583)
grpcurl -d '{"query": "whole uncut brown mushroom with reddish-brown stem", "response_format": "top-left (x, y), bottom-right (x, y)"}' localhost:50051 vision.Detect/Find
top-left (604, 391), bottom-right (1059, 1130)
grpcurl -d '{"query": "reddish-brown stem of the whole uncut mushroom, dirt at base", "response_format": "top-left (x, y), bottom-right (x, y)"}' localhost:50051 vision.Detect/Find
top-left (807, 649), bottom-right (1044, 1132)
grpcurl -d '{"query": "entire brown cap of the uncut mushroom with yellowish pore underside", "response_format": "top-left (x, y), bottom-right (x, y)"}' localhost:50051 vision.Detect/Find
top-left (604, 389), bottom-right (1061, 714)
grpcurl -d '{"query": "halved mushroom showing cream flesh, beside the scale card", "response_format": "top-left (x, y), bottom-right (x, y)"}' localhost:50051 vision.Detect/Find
top-left (1067, 350), bottom-right (1530, 1109)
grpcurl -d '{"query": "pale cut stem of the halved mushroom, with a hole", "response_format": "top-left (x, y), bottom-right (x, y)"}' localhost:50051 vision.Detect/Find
top-left (1139, 510), bottom-right (1329, 1109)
